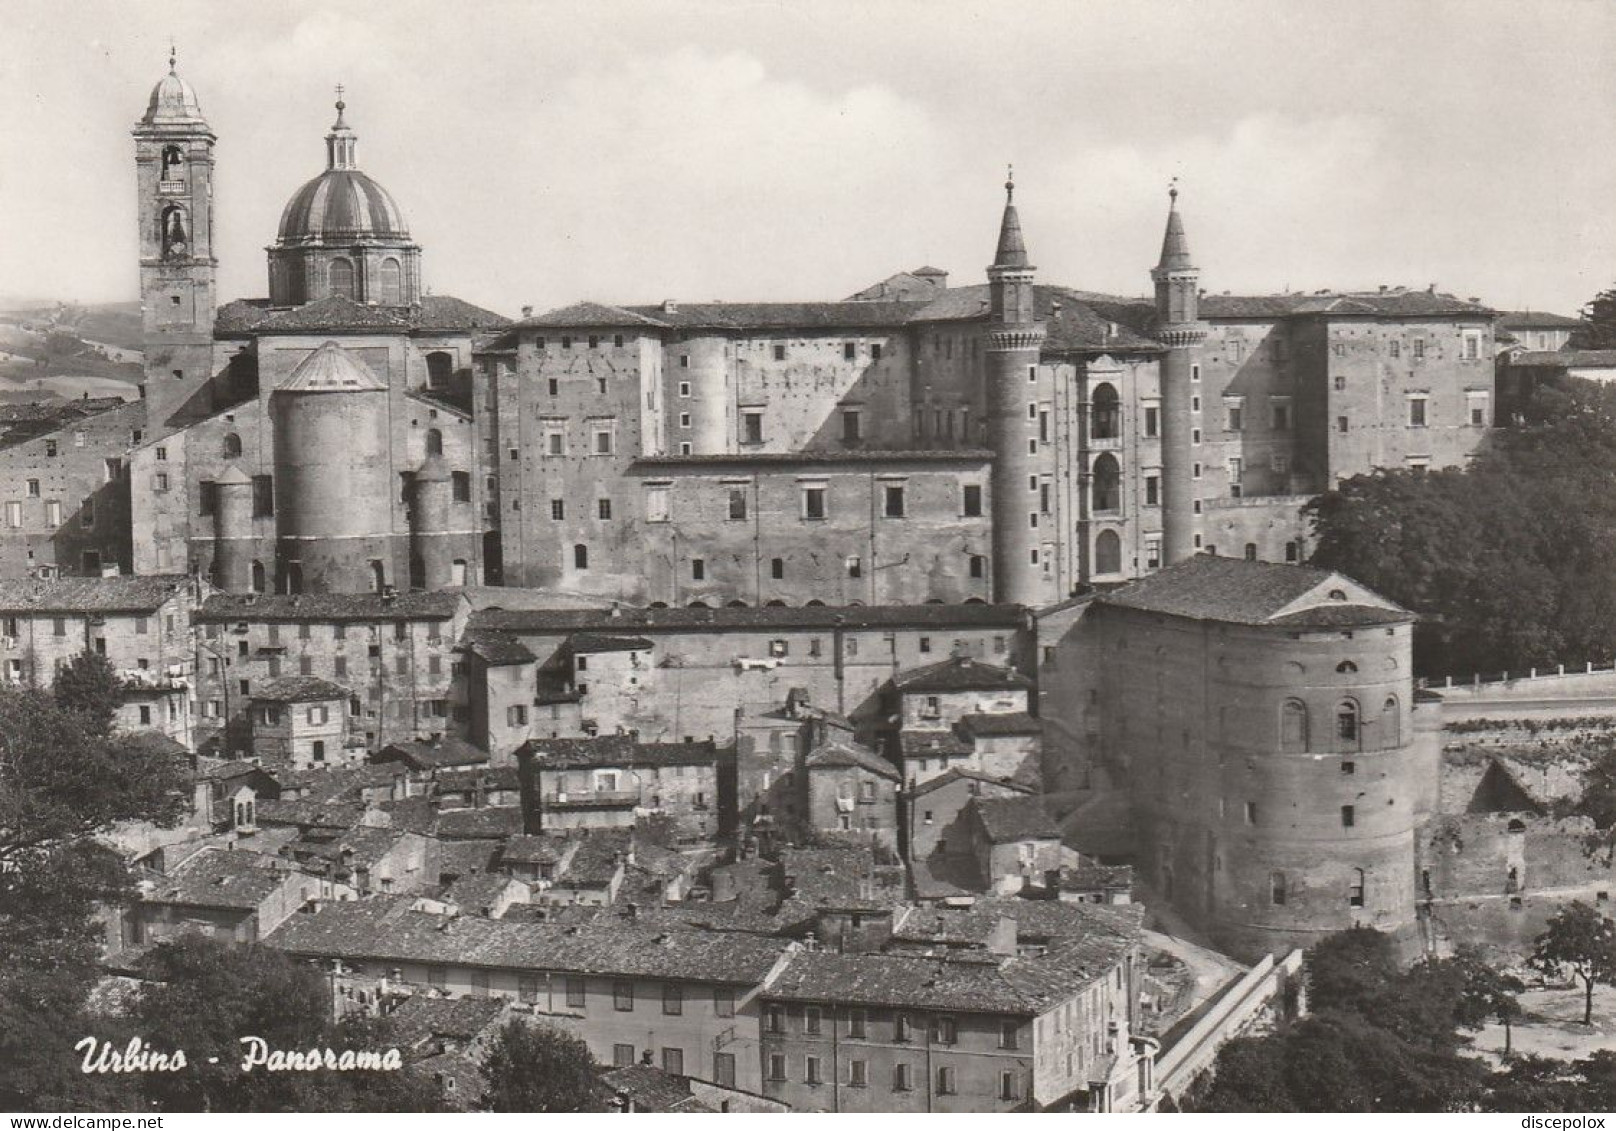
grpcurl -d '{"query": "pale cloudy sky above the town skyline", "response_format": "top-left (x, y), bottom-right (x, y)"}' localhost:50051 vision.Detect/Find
top-left (0, 0), bottom-right (1616, 313)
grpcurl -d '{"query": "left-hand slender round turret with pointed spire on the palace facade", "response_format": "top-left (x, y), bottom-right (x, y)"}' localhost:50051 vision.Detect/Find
top-left (984, 172), bottom-right (1044, 604)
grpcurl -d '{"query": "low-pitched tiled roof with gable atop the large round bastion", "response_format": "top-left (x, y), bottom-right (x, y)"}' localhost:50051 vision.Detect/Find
top-left (1096, 554), bottom-right (1414, 627)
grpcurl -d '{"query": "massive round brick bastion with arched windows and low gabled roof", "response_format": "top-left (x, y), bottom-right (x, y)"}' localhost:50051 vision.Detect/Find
top-left (1041, 554), bottom-right (1440, 957)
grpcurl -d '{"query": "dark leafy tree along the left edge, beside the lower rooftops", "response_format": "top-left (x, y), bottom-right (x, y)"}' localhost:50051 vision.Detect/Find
top-left (0, 688), bottom-right (186, 1108)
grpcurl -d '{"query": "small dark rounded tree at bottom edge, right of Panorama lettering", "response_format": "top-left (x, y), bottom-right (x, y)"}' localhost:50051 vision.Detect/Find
top-left (482, 1021), bottom-right (608, 1113)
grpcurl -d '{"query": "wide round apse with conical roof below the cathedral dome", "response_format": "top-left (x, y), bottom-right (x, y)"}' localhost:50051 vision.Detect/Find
top-left (270, 341), bottom-right (394, 593)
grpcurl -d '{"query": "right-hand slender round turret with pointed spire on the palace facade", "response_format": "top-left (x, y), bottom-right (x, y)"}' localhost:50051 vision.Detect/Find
top-left (1151, 184), bottom-right (1207, 566)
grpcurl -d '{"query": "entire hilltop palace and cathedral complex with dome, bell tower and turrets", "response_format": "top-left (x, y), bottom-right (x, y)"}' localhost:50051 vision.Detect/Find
top-left (0, 52), bottom-right (1493, 608)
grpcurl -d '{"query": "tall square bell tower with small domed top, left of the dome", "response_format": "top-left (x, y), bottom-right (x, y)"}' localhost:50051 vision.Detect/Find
top-left (131, 50), bottom-right (218, 428)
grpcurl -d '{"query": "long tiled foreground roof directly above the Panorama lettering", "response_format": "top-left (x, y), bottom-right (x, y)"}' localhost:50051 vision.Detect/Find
top-left (268, 898), bottom-right (787, 986)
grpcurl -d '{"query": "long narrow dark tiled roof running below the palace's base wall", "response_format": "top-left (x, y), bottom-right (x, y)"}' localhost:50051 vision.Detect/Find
top-left (471, 601), bottom-right (1023, 633)
